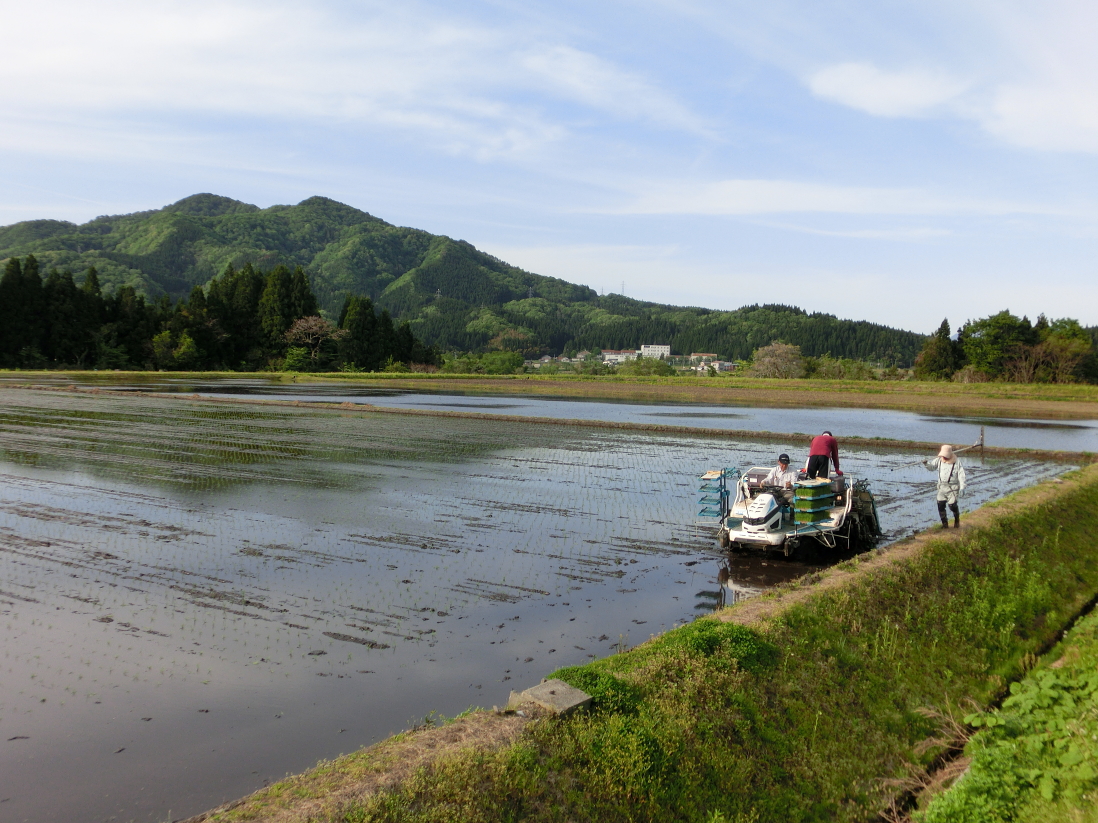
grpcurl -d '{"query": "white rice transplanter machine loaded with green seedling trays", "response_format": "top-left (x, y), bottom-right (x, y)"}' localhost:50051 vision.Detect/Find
top-left (699, 466), bottom-right (881, 557)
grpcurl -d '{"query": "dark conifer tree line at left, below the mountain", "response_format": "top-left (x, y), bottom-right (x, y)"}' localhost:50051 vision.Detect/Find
top-left (0, 255), bottom-right (440, 371)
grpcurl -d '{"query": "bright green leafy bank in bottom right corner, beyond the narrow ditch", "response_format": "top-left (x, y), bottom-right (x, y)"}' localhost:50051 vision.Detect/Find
top-left (915, 612), bottom-right (1098, 823)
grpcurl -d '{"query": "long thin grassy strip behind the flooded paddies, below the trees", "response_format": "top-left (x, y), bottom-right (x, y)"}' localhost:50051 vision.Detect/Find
top-left (4, 371), bottom-right (1098, 419)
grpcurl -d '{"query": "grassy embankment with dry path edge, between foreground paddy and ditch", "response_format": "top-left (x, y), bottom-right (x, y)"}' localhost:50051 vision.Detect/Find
top-left (197, 466), bottom-right (1098, 823)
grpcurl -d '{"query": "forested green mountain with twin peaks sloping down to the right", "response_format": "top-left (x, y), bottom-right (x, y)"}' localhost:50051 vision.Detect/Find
top-left (0, 194), bottom-right (925, 365)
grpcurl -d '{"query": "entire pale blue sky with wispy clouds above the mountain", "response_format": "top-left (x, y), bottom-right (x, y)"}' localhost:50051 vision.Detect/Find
top-left (0, 0), bottom-right (1098, 332)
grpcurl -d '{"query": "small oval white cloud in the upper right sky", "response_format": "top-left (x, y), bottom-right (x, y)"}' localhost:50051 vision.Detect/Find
top-left (808, 63), bottom-right (965, 117)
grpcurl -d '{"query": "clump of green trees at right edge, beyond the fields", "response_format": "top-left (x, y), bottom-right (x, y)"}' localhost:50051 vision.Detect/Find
top-left (915, 311), bottom-right (1098, 383)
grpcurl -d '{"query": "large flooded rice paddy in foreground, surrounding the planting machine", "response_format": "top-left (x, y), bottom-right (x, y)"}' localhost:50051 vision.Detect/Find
top-left (0, 390), bottom-right (1080, 821)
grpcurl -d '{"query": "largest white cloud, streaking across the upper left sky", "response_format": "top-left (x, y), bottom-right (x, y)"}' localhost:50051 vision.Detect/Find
top-left (0, 0), bottom-right (699, 159)
